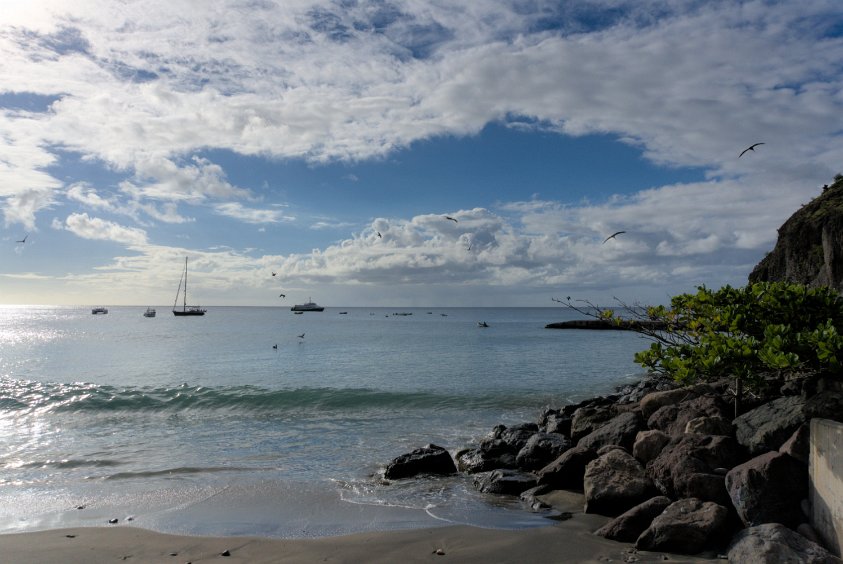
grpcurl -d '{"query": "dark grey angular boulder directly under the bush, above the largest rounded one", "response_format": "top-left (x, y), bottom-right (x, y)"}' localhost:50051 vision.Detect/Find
top-left (733, 396), bottom-right (807, 456)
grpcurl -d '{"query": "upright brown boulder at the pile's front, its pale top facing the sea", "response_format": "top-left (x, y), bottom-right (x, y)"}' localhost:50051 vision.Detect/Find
top-left (583, 448), bottom-right (656, 516)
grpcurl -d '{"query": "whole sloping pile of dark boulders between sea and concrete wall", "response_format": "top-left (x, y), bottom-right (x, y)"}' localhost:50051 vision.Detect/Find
top-left (384, 375), bottom-right (843, 563)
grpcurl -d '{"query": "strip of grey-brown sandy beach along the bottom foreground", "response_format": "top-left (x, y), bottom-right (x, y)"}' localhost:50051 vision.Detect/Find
top-left (0, 492), bottom-right (716, 564)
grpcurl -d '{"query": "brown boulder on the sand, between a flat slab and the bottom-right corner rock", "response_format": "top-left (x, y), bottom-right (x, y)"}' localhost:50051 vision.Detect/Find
top-left (635, 498), bottom-right (729, 554)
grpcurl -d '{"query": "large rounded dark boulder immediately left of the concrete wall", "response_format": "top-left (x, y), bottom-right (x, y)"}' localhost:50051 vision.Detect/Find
top-left (726, 452), bottom-right (808, 529)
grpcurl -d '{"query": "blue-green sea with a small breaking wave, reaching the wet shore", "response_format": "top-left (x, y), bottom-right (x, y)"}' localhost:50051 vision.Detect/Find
top-left (0, 306), bottom-right (648, 538)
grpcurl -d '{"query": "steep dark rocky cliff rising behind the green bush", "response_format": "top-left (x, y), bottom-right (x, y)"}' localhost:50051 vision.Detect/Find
top-left (749, 179), bottom-right (843, 292)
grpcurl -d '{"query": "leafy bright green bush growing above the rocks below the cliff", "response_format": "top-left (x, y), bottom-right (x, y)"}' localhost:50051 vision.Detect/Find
top-left (635, 282), bottom-right (843, 388)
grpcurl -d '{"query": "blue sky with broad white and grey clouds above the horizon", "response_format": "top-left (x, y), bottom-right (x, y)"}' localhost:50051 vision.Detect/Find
top-left (0, 0), bottom-right (843, 307)
